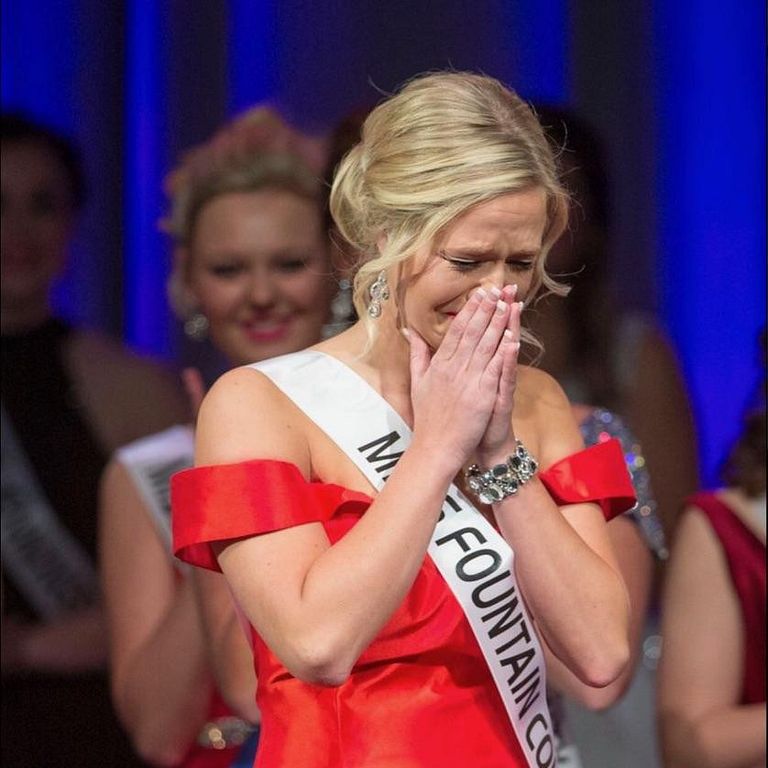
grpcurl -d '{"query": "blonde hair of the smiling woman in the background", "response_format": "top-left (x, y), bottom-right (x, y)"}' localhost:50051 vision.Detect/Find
top-left (160, 106), bottom-right (325, 319)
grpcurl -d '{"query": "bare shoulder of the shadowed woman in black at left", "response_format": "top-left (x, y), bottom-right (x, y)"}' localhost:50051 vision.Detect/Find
top-left (68, 331), bottom-right (189, 451)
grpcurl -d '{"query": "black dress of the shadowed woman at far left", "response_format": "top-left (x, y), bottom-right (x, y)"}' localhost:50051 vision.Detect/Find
top-left (0, 319), bottom-right (150, 768)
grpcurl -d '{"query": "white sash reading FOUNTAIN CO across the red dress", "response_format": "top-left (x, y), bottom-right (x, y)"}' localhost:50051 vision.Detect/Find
top-left (250, 350), bottom-right (557, 768)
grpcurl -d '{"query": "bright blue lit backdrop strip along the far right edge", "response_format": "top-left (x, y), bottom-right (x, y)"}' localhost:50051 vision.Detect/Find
top-left (654, 0), bottom-right (766, 485)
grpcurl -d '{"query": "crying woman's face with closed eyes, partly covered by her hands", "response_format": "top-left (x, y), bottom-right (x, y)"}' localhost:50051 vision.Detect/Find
top-left (397, 188), bottom-right (547, 349)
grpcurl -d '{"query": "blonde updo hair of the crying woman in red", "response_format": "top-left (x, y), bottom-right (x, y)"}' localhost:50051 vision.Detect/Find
top-left (330, 72), bottom-right (568, 349)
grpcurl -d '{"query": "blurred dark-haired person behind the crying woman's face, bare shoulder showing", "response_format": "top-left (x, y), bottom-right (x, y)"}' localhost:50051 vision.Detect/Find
top-left (529, 106), bottom-right (699, 537)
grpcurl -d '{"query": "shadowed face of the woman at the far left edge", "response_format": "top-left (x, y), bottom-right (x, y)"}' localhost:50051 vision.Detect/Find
top-left (0, 140), bottom-right (75, 311)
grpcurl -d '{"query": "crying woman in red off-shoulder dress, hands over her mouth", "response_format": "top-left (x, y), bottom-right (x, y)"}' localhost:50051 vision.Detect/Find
top-left (173, 73), bottom-right (632, 768)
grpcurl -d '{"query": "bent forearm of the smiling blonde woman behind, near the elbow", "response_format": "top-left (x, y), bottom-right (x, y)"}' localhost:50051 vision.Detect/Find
top-left (112, 583), bottom-right (211, 765)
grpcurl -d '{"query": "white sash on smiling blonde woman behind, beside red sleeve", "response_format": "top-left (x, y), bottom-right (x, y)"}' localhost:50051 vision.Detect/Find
top-left (117, 426), bottom-right (195, 556)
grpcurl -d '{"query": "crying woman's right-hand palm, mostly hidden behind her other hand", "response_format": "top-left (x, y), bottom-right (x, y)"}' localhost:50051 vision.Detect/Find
top-left (477, 285), bottom-right (522, 467)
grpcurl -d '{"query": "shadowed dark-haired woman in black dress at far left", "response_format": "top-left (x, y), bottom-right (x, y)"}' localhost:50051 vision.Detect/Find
top-left (0, 114), bottom-right (188, 768)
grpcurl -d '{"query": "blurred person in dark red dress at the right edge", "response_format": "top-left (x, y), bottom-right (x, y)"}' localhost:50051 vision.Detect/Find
top-left (659, 332), bottom-right (766, 768)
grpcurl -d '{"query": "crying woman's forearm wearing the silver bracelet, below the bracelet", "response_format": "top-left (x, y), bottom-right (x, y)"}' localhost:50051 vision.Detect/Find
top-left (495, 479), bottom-right (629, 687)
